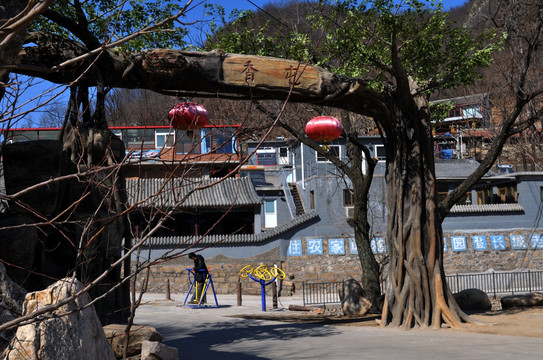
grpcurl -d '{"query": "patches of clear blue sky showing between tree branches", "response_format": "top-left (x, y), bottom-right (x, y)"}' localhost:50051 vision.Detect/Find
top-left (12, 0), bottom-right (468, 127)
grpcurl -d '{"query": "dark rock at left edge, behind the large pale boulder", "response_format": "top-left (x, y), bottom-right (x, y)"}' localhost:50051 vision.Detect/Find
top-left (0, 262), bottom-right (26, 354)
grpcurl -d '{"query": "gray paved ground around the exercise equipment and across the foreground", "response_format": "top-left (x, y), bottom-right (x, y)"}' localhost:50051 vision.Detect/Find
top-left (136, 294), bottom-right (543, 360)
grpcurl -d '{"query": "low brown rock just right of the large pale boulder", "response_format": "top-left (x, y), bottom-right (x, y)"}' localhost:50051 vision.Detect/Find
top-left (104, 324), bottom-right (162, 359)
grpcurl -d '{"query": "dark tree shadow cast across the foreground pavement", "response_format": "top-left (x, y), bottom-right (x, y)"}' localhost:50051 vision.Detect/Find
top-left (157, 319), bottom-right (337, 360)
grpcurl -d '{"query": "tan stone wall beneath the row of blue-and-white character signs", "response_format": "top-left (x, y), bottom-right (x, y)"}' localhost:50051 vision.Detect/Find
top-left (135, 231), bottom-right (543, 301)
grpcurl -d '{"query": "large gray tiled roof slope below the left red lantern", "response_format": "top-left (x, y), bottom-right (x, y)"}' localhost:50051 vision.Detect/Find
top-left (126, 177), bottom-right (261, 208)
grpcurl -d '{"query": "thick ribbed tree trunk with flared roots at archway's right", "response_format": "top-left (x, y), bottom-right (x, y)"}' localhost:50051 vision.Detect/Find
top-left (380, 93), bottom-right (469, 328)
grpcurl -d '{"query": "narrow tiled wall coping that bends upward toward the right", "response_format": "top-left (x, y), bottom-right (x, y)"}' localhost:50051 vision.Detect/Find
top-left (148, 210), bottom-right (324, 246)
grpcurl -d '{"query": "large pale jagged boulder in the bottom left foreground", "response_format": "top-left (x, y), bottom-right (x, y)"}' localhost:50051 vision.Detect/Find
top-left (2, 278), bottom-right (115, 360)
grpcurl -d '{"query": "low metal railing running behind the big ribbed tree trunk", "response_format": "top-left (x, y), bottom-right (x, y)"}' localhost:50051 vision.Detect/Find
top-left (302, 270), bottom-right (543, 306)
